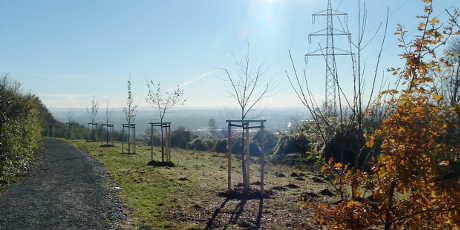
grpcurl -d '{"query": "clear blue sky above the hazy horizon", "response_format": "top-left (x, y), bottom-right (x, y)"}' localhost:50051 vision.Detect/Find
top-left (0, 0), bottom-right (460, 111)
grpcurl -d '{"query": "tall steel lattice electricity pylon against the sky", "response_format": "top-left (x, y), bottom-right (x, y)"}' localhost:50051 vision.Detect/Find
top-left (305, 0), bottom-right (352, 115)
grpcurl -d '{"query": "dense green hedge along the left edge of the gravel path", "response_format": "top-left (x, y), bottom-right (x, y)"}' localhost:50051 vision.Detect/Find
top-left (0, 74), bottom-right (42, 185)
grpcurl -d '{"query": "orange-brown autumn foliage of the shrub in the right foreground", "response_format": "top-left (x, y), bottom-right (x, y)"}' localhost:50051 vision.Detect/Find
top-left (304, 0), bottom-right (460, 229)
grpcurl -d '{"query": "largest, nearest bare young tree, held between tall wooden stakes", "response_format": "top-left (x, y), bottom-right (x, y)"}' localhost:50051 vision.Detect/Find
top-left (224, 42), bottom-right (276, 194)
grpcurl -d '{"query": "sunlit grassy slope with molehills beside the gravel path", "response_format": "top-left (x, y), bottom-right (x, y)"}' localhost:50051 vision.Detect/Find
top-left (71, 140), bottom-right (333, 229)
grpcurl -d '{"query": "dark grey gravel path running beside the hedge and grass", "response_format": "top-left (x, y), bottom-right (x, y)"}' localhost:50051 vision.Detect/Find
top-left (0, 139), bottom-right (126, 229)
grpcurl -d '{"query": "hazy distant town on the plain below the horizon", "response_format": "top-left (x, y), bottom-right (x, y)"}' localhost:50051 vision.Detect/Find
top-left (51, 107), bottom-right (311, 137)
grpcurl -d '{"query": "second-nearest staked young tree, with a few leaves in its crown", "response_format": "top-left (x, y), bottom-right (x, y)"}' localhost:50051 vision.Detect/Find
top-left (146, 81), bottom-right (187, 161)
